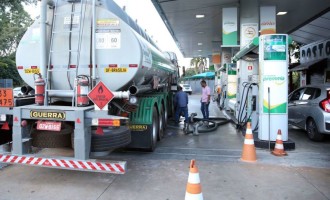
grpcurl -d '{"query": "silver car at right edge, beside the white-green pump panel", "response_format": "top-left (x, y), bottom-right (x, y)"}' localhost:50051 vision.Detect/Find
top-left (288, 84), bottom-right (330, 141)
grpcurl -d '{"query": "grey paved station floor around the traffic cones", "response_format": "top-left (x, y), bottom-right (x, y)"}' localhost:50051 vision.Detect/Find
top-left (0, 95), bottom-right (330, 200)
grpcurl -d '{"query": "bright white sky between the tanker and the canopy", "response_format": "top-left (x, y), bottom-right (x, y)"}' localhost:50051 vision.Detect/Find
top-left (25, 0), bottom-right (191, 67)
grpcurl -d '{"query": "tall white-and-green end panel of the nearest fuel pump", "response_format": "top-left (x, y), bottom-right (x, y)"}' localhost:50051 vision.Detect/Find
top-left (258, 34), bottom-right (289, 141)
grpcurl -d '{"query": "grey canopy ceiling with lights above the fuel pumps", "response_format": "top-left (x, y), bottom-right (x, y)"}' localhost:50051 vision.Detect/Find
top-left (152, 0), bottom-right (330, 57)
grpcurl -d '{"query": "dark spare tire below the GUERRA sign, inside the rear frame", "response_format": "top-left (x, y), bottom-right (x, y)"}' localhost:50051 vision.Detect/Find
top-left (31, 124), bottom-right (73, 148)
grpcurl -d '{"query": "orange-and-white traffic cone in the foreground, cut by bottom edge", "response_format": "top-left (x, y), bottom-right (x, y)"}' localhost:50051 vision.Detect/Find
top-left (185, 160), bottom-right (203, 200)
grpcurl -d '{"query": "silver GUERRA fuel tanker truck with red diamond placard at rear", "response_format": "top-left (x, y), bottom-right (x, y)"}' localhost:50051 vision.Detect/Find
top-left (0, 0), bottom-right (178, 174)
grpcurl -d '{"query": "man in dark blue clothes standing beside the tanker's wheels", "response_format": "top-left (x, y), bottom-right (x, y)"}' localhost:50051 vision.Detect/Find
top-left (174, 86), bottom-right (189, 124)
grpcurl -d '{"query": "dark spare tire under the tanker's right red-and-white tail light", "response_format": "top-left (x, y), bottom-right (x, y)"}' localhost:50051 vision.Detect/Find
top-left (91, 126), bottom-right (131, 152)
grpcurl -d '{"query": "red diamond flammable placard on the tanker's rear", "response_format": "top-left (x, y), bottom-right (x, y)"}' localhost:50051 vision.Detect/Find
top-left (87, 81), bottom-right (115, 110)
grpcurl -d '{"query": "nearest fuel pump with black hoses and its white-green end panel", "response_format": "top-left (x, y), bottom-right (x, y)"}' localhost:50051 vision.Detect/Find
top-left (228, 34), bottom-right (295, 149)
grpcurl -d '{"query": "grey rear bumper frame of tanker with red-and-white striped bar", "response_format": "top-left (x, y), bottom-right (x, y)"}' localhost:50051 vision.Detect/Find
top-left (0, 105), bottom-right (128, 174)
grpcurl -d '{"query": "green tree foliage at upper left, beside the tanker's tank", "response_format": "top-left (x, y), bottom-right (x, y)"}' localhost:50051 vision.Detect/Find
top-left (0, 0), bottom-right (37, 85)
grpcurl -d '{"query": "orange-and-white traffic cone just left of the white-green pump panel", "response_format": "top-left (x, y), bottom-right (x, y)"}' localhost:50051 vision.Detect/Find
top-left (241, 122), bottom-right (257, 162)
